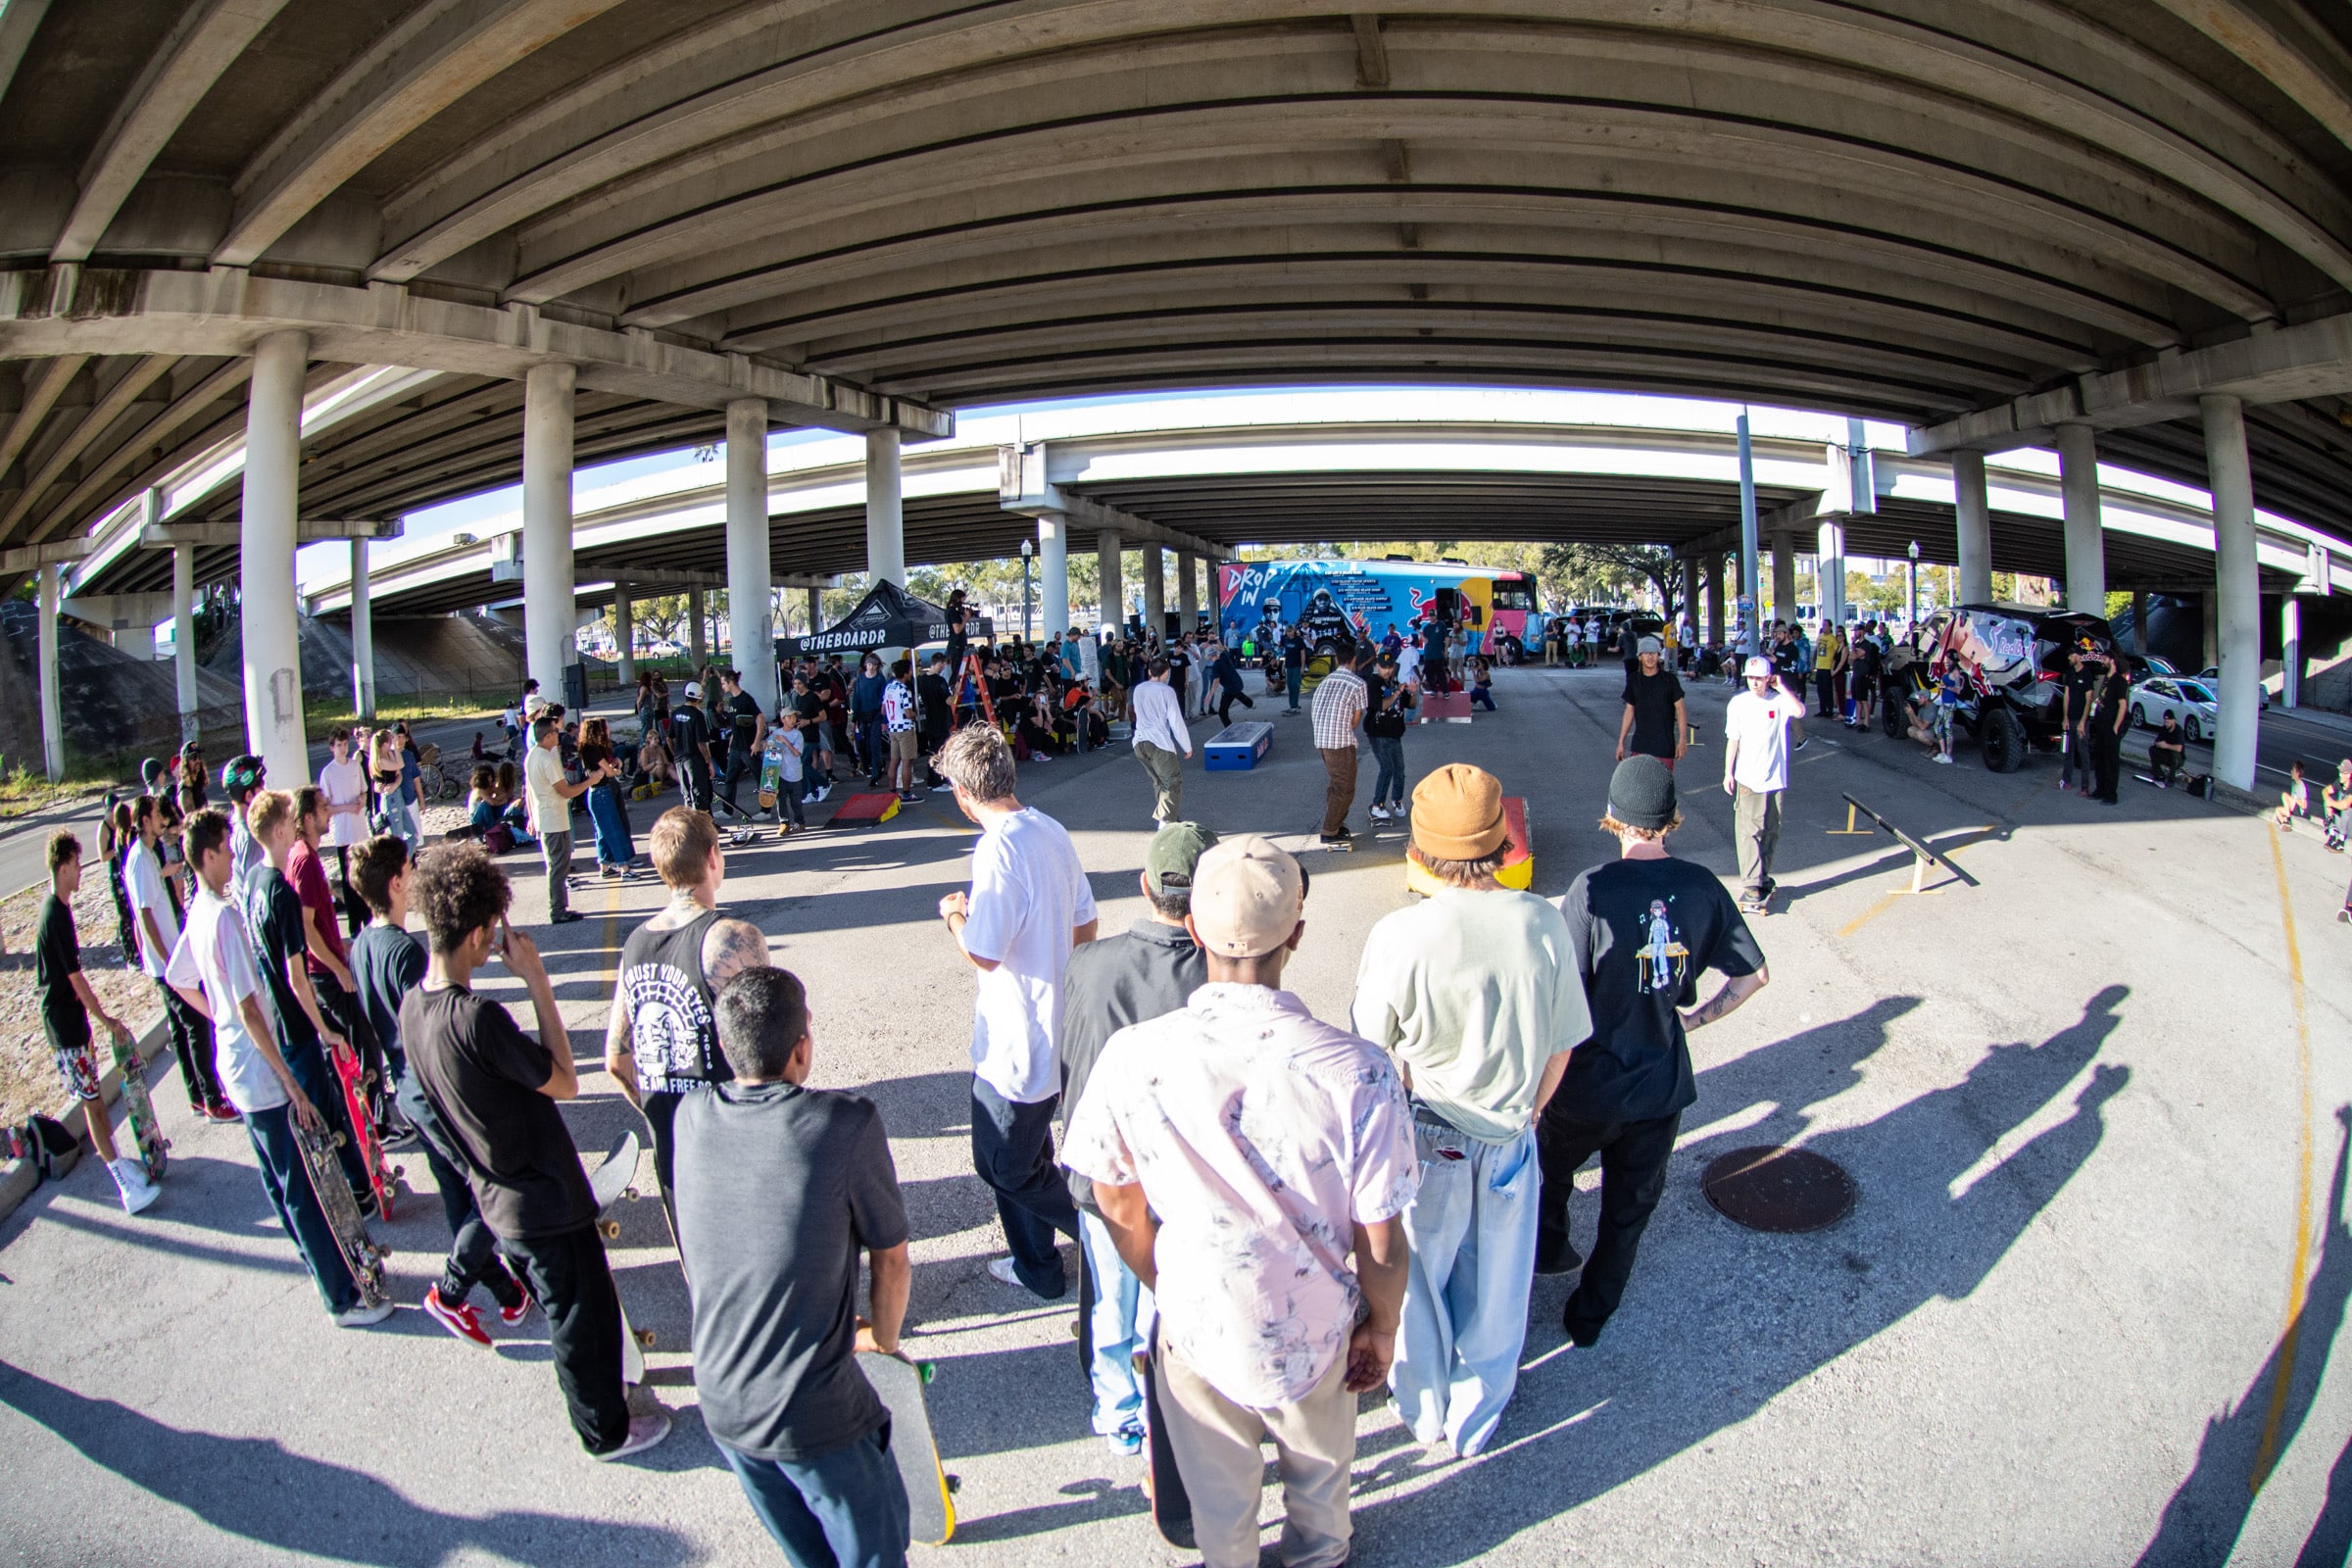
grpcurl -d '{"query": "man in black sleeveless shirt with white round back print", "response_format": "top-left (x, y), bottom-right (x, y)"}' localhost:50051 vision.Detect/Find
top-left (605, 807), bottom-right (766, 1215)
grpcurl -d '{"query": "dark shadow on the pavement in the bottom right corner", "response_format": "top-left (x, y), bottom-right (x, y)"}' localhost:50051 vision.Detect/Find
top-left (2138, 1107), bottom-right (2352, 1568)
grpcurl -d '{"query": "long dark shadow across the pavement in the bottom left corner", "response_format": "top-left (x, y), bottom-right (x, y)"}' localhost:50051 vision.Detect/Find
top-left (0, 1363), bottom-right (699, 1568)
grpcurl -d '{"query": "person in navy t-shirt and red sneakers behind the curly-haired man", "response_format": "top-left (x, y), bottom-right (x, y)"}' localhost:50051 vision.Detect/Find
top-left (351, 832), bottom-right (531, 1348)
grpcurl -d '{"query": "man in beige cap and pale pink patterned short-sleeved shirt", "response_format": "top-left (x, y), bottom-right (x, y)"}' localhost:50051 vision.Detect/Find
top-left (1063, 835), bottom-right (1421, 1568)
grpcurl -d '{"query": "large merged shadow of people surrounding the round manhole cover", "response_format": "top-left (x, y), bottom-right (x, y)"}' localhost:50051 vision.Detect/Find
top-left (1357, 987), bottom-right (2129, 1563)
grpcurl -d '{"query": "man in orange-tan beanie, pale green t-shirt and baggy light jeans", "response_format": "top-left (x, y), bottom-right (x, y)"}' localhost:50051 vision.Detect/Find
top-left (1354, 761), bottom-right (1592, 1457)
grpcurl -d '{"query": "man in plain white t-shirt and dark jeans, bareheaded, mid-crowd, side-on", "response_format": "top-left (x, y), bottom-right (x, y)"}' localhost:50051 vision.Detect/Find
top-left (934, 724), bottom-right (1096, 1300)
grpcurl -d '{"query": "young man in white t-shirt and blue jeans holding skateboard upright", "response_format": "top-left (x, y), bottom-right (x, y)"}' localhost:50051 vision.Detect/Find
top-left (165, 811), bottom-right (393, 1328)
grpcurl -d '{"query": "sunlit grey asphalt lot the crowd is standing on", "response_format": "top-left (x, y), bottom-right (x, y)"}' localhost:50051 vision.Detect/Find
top-left (0, 670), bottom-right (2352, 1566)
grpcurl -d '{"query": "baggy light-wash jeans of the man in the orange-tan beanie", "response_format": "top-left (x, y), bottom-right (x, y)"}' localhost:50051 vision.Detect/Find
top-left (1388, 1104), bottom-right (1539, 1457)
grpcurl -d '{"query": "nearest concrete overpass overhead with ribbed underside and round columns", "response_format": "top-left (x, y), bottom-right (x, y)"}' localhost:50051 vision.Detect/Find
top-left (14, 0), bottom-right (2352, 778)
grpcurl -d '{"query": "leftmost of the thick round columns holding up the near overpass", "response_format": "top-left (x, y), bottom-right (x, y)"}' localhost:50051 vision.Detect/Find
top-left (237, 331), bottom-right (311, 790)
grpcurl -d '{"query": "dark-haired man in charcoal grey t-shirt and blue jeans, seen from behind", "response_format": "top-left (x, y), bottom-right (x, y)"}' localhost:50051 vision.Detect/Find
top-left (675, 964), bottom-right (915, 1563)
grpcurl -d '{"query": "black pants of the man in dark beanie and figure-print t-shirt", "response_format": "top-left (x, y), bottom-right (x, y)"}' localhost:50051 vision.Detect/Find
top-left (1536, 1098), bottom-right (1682, 1348)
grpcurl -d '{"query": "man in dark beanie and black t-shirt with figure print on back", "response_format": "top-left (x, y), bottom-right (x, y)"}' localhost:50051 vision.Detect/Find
top-left (1536, 755), bottom-right (1769, 1348)
